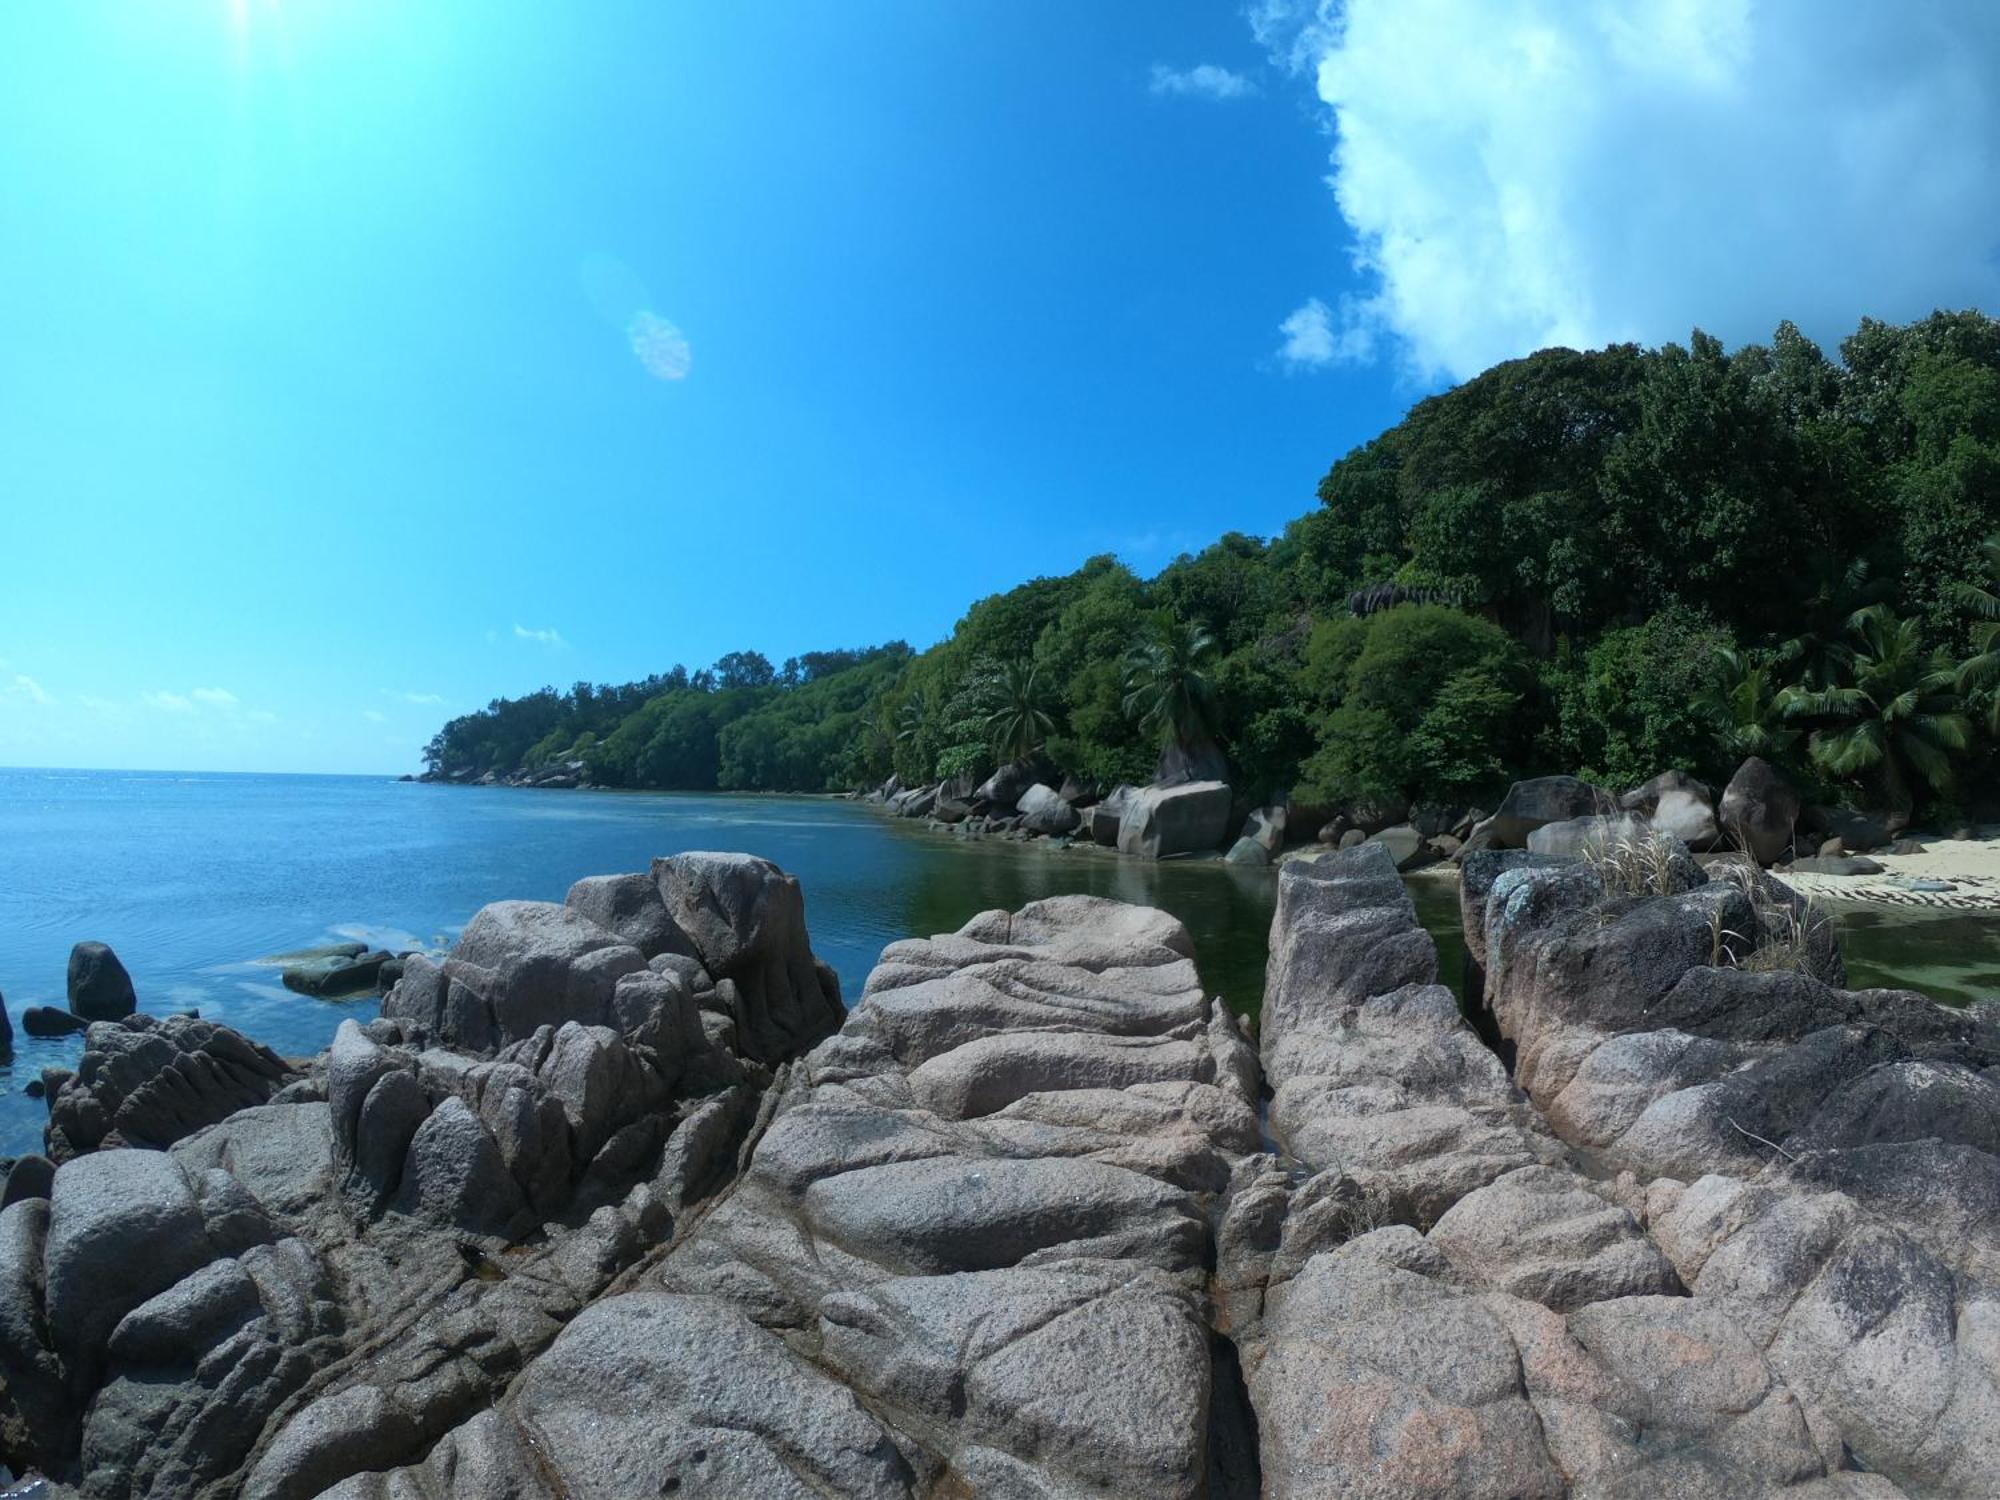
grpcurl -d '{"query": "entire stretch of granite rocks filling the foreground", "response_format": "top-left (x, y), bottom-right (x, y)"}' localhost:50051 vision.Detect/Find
top-left (0, 840), bottom-right (2000, 1500)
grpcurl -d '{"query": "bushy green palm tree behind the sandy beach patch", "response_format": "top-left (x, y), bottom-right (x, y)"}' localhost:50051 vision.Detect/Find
top-left (1782, 604), bottom-right (1972, 812)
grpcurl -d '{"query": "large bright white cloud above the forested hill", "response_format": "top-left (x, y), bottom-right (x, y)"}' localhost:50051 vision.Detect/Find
top-left (1250, 0), bottom-right (2000, 380)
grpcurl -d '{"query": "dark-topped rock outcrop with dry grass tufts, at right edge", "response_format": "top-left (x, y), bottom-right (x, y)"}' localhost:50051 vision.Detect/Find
top-left (1464, 840), bottom-right (2000, 1496)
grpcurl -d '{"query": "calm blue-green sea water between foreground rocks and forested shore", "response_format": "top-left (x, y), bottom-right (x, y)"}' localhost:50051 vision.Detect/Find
top-left (0, 770), bottom-right (2000, 1156)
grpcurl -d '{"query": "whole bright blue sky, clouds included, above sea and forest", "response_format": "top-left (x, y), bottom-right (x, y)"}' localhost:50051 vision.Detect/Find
top-left (0, 0), bottom-right (2000, 770)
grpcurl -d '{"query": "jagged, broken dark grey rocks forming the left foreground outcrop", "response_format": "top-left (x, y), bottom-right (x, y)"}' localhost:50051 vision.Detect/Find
top-left (0, 856), bottom-right (838, 1500)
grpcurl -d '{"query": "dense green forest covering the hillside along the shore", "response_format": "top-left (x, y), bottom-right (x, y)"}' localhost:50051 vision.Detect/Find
top-left (424, 312), bottom-right (2000, 818)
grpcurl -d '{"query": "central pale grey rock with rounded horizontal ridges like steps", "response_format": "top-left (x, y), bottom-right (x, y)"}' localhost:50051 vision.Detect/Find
top-left (338, 896), bottom-right (1258, 1500)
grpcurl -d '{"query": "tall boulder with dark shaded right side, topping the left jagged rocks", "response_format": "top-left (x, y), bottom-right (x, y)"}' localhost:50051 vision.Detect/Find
top-left (652, 852), bottom-right (846, 1062)
